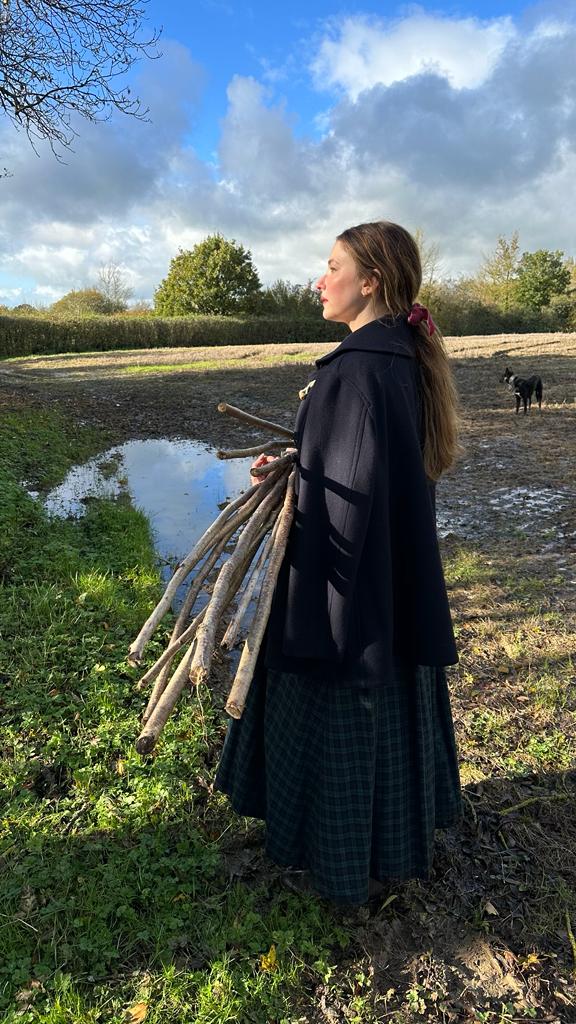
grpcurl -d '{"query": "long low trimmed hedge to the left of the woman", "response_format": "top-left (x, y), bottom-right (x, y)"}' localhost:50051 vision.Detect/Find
top-left (0, 314), bottom-right (347, 357)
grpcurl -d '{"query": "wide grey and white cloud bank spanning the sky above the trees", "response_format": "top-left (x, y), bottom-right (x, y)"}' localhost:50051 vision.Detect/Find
top-left (0, 12), bottom-right (576, 302)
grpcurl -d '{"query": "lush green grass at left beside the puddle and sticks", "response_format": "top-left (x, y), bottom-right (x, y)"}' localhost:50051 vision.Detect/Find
top-left (0, 413), bottom-right (358, 1024)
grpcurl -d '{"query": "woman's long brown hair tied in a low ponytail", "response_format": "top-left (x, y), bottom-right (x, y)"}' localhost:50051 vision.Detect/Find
top-left (338, 220), bottom-right (460, 480)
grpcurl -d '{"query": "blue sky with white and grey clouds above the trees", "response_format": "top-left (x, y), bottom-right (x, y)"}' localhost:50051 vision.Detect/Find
top-left (0, 0), bottom-right (576, 306)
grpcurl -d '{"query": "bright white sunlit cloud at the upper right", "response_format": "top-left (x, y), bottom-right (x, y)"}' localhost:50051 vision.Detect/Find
top-left (311, 8), bottom-right (518, 100)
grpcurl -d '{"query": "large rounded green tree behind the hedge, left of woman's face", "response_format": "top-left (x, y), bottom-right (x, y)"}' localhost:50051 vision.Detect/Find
top-left (154, 234), bottom-right (260, 316)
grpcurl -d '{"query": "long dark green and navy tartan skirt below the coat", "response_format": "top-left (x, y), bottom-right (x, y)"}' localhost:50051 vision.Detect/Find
top-left (214, 665), bottom-right (460, 903)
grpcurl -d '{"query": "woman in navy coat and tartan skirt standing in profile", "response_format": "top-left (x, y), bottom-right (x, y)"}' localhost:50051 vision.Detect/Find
top-left (215, 221), bottom-right (460, 903)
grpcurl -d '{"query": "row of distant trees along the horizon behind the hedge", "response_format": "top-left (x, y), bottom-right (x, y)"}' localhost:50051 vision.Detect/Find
top-left (0, 230), bottom-right (576, 334)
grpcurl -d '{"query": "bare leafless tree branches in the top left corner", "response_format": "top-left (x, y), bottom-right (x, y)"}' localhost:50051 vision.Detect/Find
top-left (0, 0), bottom-right (158, 148)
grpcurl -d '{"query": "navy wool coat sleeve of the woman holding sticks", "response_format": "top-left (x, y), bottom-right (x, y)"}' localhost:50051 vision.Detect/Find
top-left (282, 375), bottom-right (386, 662)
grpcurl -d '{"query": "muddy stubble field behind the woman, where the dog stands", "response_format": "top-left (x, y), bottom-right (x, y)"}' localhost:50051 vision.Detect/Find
top-left (0, 334), bottom-right (576, 579)
